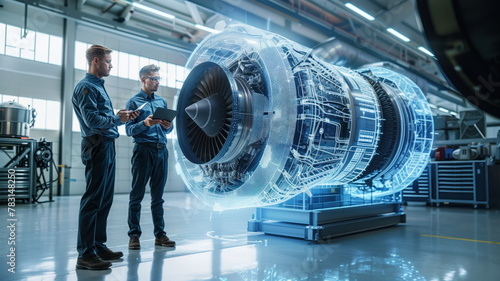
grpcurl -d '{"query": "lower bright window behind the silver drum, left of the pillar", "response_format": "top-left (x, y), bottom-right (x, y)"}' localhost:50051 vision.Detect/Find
top-left (0, 95), bottom-right (61, 130)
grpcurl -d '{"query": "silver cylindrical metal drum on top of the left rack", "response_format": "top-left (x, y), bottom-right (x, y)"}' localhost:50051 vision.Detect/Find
top-left (0, 101), bottom-right (35, 138)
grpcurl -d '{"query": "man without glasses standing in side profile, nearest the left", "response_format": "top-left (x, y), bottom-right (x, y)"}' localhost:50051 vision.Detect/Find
top-left (72, 45), bottom-right (137, 270)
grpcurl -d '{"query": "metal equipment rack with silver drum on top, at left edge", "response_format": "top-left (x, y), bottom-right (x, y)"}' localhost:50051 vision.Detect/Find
top-left (0, 101), bottom-right (55, 203)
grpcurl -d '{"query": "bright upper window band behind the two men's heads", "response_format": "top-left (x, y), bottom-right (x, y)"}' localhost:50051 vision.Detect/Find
top-left (75, 41), bottom-right (187, 89)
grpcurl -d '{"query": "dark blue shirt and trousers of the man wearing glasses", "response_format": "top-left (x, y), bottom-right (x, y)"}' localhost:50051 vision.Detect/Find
top-left (126, 90), bottom-right (173, 238)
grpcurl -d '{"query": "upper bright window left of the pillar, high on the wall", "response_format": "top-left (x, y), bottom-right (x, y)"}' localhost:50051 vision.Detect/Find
top-left (0, 24), bottom-right (62, 65)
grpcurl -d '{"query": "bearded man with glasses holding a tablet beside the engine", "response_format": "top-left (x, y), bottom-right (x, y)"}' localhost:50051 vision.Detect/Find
top-left (126, 64), bottom-right (175, 250)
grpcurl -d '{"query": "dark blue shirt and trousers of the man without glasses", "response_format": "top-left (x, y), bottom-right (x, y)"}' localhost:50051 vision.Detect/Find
top-left (72, 73), bottom-right (122, 258)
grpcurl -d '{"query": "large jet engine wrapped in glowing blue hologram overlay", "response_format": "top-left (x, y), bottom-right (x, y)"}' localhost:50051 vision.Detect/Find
top-left (173, 25), bottom-right (433, 209)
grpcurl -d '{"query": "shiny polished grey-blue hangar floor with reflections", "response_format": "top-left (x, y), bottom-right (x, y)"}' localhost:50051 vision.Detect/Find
top-left (0, 192), bottom-right (500, 281)
